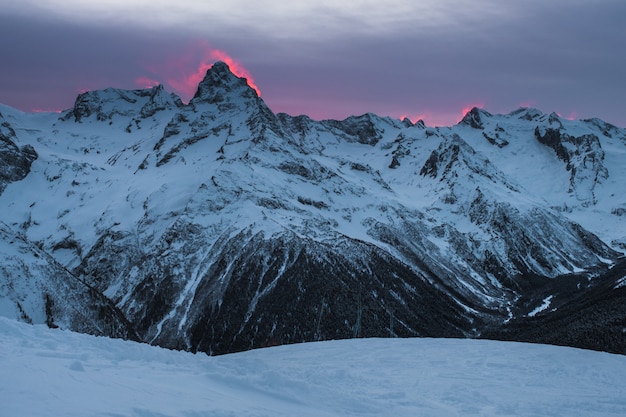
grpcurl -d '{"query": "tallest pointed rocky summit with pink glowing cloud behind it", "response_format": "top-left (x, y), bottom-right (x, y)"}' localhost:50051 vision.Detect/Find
top-left (191, 61), bottom-right (259, 104)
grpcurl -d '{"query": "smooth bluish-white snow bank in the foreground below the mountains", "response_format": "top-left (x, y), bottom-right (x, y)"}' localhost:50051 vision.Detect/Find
top-left (0, 317), bottom-right (626, 417)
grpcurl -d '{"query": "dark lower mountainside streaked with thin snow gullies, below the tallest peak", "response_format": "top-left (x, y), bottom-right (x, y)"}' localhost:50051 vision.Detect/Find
top-left (75, 224), bottom-right (480, 353)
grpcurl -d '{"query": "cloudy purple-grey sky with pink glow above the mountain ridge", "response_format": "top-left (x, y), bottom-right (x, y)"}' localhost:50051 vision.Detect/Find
top-left (0, 0), bottom-right (626, 127)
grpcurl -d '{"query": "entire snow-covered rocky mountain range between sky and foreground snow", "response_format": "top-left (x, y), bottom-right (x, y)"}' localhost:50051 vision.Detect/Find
top-left (0, 63), bottom-right (626, 353)
